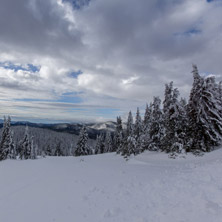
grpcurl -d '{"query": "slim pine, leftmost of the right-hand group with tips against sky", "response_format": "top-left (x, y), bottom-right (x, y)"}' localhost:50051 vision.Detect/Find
top-left (113, 116), bottom-right (123, 153)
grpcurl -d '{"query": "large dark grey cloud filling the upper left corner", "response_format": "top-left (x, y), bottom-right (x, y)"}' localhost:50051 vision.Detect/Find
top-left (0, 0), bottom-right (82, 60)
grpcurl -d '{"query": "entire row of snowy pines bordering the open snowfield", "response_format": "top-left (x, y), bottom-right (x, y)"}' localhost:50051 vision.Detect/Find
top-left (0, 65), bottom-right (222, 160)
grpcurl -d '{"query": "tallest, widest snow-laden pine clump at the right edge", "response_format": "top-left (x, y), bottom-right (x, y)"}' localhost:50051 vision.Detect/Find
top-left (188, 65), bottom-right (222, 152)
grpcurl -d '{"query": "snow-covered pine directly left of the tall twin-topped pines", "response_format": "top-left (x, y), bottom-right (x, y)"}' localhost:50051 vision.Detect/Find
top-left (148, 97), bottom-right (164, 151)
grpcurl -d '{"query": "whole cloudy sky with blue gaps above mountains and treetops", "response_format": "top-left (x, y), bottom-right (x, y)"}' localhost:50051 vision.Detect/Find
top-left (0, 0), bottom-right (222, 122)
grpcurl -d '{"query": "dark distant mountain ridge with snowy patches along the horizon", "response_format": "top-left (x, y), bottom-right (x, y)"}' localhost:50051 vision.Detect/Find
top-left (0, 120), bottom-right (116, 139)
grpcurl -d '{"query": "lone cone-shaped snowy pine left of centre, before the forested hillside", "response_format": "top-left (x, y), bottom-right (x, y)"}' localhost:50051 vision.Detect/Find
top-left (74, 126), bottom-right (89, 156)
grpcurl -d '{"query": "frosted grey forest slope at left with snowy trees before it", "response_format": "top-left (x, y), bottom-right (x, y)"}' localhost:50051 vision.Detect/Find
top-left (0, 120), bottom-right (95, 160)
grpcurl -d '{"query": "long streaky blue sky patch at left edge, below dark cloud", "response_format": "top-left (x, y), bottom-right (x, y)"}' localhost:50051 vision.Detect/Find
top-left (0, 62), bottom-right (41, 72)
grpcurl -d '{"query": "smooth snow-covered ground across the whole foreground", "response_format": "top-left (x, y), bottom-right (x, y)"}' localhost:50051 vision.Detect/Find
top-left (0, 149), bottom-right (222, 222)
